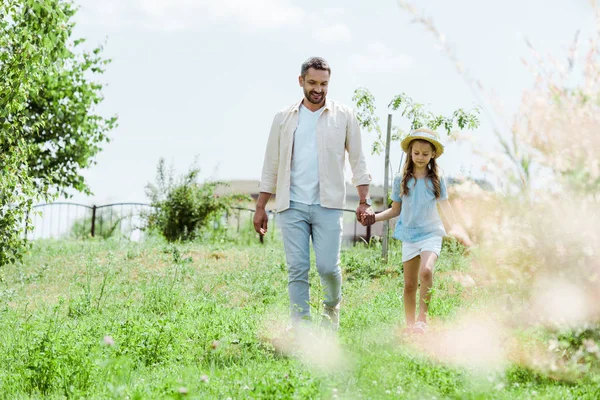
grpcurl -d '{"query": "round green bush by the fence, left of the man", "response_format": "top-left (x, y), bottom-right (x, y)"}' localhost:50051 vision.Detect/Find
top-left (146, 159), bottom-right (250, 242)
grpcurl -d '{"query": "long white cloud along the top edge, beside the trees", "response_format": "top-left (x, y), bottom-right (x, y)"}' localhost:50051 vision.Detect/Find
top-left (82, 0), bottom-right (306, 30)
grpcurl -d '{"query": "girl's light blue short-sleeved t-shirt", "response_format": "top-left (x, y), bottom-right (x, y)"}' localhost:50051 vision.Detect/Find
top-left (392, 175), bottom-right (448, 243)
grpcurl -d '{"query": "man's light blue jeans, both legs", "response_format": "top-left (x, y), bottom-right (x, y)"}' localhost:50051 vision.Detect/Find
top-left (277, 201), bottom-right (343, 320)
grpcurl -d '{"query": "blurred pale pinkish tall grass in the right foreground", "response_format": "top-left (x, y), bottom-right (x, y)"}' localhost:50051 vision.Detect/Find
top-left (398, 0), bottom-right (600, 382)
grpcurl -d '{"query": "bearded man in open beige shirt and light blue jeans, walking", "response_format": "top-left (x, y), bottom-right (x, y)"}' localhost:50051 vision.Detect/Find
top-left (254, 57), bottom-right (374, 330)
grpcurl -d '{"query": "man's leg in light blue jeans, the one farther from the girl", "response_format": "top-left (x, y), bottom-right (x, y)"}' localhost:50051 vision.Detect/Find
top-left (278, 204), bottom-right (310, 323)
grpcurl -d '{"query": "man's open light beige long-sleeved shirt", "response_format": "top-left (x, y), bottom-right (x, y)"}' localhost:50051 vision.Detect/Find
top-left (259, 100), bottom-right (371, 212)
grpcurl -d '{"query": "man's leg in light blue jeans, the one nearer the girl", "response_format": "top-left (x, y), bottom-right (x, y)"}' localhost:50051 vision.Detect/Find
top-left (311, 206), bottom-right (343, 325)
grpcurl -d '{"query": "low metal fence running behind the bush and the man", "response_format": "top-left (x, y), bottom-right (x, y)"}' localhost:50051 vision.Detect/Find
top-left (27, 202), bottom-right (382, 245)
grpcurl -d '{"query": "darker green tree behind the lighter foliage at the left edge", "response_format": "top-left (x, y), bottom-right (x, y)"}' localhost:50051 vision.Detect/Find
top-left (23, 0), bottom-right (117, 195)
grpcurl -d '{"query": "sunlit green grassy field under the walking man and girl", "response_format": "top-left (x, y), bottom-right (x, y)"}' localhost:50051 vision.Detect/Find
top-left (0, 236), bottom-right (600, 400)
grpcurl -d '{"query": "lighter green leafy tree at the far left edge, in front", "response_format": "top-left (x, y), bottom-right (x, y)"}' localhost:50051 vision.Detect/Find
top-left (0, 0), bottom-right (69, 265)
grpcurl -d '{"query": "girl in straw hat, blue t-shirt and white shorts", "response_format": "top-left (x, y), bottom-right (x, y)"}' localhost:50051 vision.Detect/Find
top-left (362, 128), bottom-right (471, 333)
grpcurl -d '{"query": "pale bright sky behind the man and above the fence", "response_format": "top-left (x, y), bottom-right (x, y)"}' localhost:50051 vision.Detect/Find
top-left (67, 0), bottom-right (594, 205)
